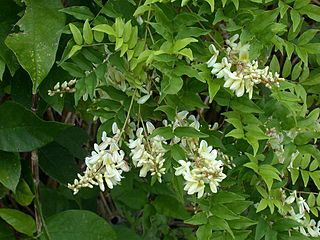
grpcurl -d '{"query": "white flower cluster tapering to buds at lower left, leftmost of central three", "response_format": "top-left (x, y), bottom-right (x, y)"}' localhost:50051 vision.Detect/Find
top-left (68, 123), bottom-right (129, 194)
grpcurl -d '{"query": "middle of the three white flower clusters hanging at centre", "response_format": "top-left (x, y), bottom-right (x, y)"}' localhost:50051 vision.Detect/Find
top-left (129, 122), bottom-right (166, 183)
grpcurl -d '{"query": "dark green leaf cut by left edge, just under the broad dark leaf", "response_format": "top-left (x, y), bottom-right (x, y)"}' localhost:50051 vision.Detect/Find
top-left (0, 151), bottom-right (21, 192)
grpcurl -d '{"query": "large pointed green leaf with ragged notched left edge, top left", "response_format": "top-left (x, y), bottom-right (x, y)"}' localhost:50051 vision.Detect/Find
top-left (5, 0), bottom-right (65, 93)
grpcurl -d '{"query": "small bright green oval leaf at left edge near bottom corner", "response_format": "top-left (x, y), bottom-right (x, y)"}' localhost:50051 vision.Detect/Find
top-left (0, 208), bottom-right (36, 236)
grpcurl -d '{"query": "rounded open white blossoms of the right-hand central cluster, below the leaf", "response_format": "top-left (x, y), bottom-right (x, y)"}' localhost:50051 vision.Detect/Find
top-left (175, 140), bottom-right (226, 198)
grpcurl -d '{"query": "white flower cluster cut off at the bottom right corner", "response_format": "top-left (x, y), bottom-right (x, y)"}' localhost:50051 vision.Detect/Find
top-left (283, 191), bottom-right (320, 237)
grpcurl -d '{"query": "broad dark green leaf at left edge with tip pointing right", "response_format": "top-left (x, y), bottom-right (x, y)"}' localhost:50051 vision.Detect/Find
top-left (0, 101), bottom-right (70, 152)
